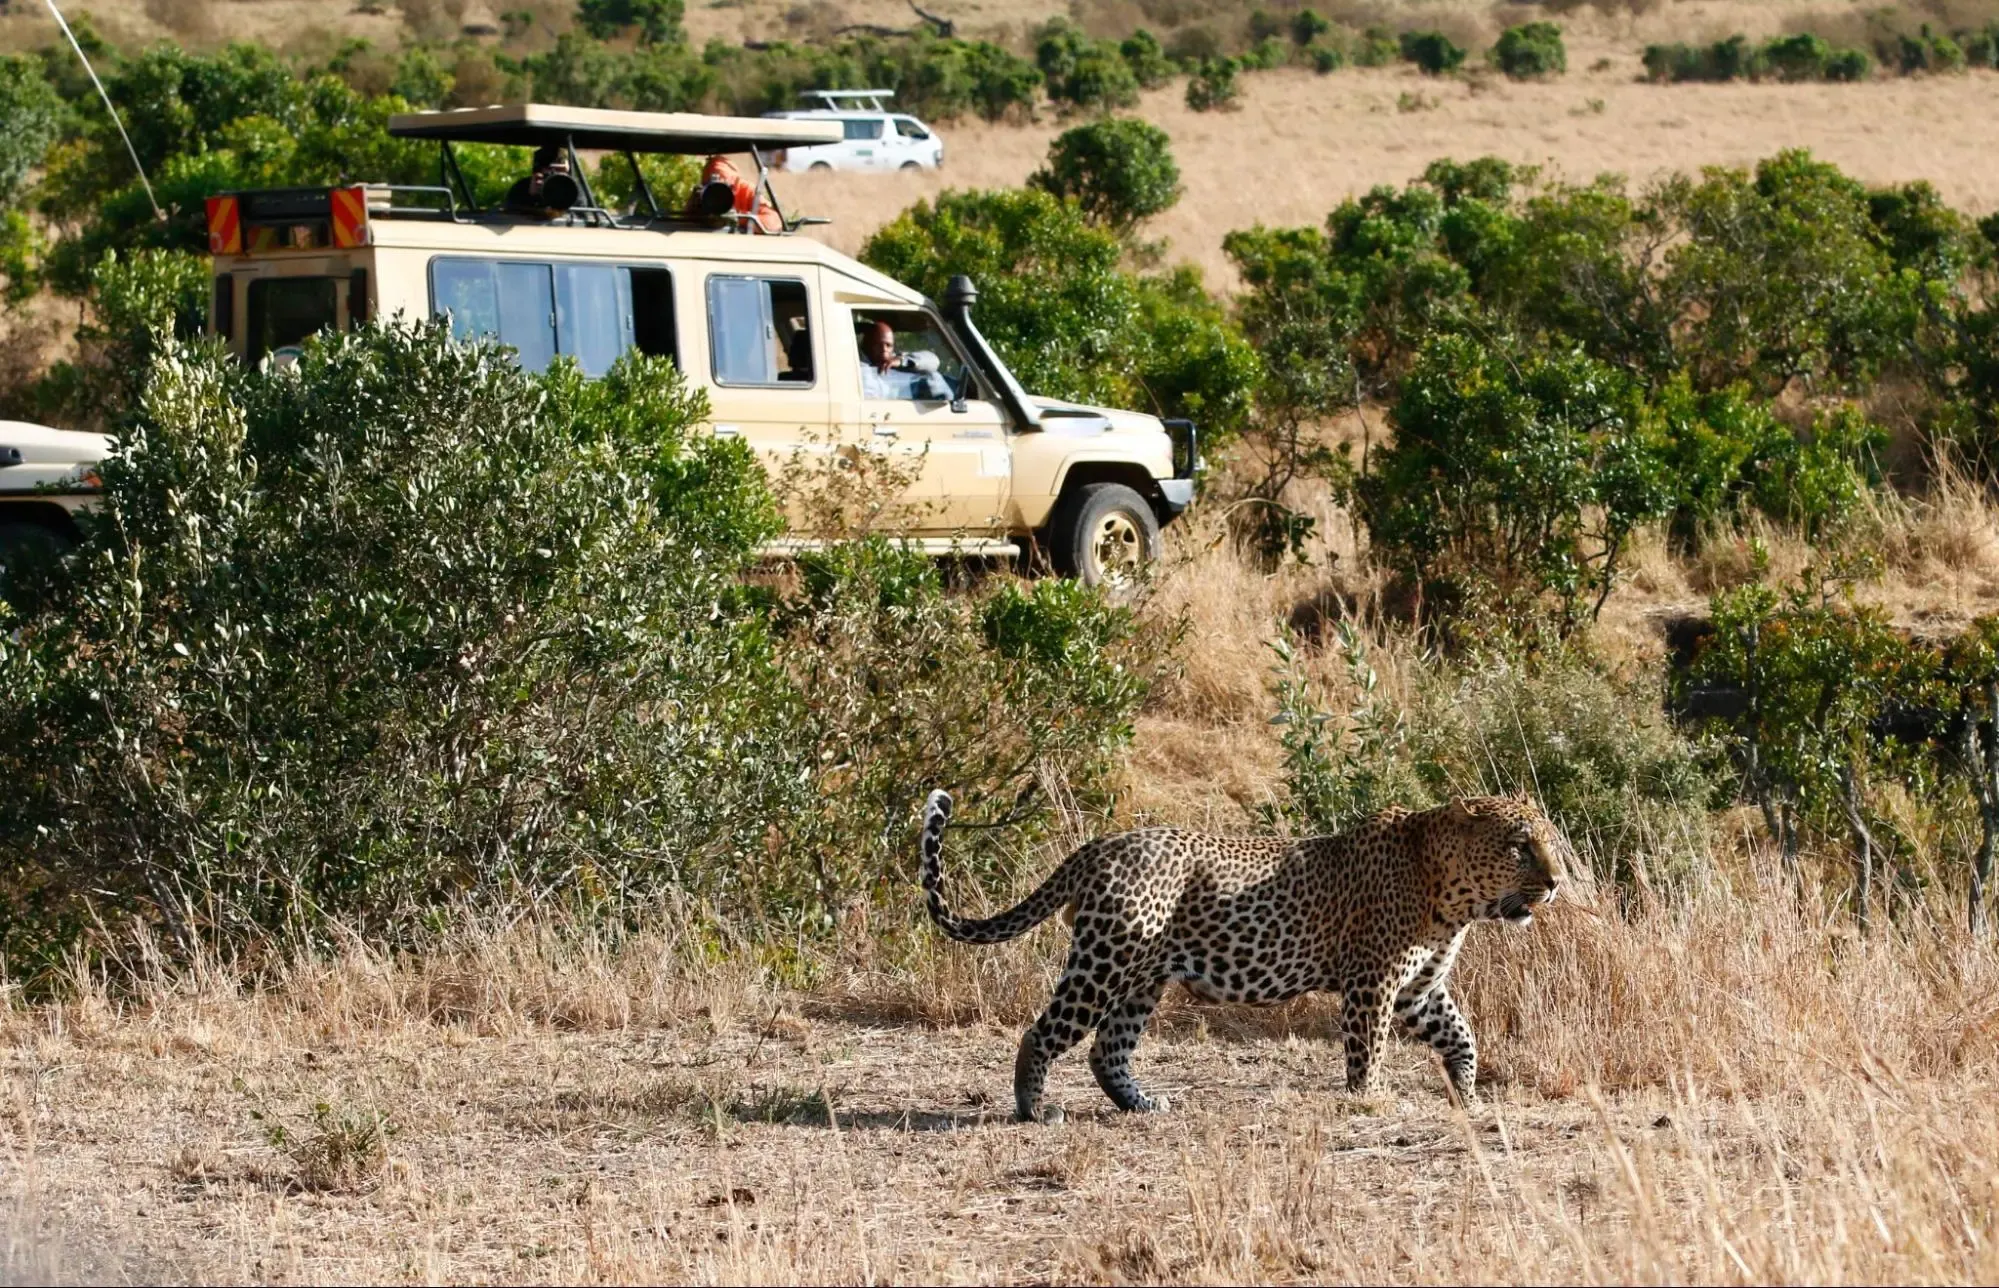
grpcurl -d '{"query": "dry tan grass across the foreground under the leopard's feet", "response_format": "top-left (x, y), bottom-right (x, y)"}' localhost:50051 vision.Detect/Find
top-left (11, 852), bottom-right (1999, 1282)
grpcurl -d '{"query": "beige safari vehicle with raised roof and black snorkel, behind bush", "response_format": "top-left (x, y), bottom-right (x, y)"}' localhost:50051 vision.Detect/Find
top-left (19, 104), bottom-right (1197, 582)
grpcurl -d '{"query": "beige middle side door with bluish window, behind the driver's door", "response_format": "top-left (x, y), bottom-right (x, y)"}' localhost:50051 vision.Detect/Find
top-left (682, 264), bottom-right (844, 532)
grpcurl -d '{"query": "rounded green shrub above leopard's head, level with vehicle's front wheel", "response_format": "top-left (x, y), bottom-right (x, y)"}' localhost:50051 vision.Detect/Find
top-left (1359, 334), bottom-right (1673, 630)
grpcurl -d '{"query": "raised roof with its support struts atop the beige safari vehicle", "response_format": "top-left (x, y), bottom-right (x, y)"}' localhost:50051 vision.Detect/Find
top-left (388, 102), bottom-right (844, 232)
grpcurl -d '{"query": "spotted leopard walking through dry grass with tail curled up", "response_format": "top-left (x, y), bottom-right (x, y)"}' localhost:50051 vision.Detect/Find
top-left (920, 790), bottom-right (1573, 1122)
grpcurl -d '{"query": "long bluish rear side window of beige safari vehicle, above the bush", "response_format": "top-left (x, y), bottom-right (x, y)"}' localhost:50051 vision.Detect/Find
top-left (430, 258), bottom-right (678, 378)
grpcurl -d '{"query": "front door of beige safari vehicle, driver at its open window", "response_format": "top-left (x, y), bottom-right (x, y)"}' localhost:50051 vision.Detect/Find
top-left (828, 296), bottom-right (1013, 538)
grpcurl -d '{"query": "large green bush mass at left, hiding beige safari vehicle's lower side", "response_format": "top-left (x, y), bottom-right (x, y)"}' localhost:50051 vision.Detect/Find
top-left (0, 326), bottom-right (1169, 970)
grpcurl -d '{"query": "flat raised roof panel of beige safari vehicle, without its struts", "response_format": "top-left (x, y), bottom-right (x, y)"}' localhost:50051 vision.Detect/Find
top-left (388, 102), bottom-right (844, 156)
